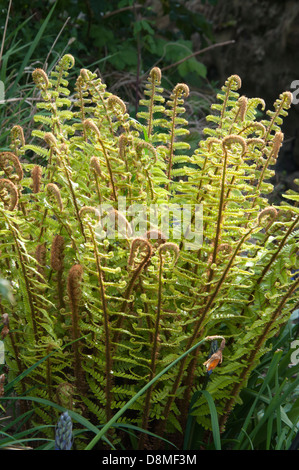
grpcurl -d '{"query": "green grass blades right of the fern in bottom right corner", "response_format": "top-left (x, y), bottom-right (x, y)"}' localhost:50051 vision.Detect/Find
top-left (222, 310), bottom-right (299, 450)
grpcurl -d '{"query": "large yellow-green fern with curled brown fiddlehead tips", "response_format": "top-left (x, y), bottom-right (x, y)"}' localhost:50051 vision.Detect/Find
top-left (0, 55), bottom-right (299, 449)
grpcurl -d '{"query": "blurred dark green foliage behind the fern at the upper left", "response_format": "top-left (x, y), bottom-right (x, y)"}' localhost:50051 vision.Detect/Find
top-left (1, 0), bottom-right (213, 79)
